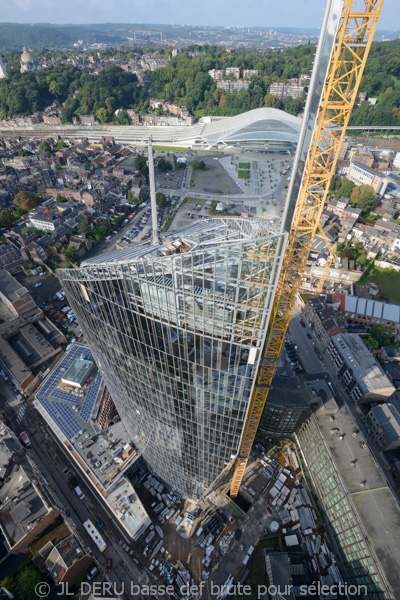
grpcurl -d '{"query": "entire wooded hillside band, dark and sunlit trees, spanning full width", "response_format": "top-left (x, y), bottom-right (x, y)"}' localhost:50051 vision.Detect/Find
top-left (0, 39), bottom-right (400, 125)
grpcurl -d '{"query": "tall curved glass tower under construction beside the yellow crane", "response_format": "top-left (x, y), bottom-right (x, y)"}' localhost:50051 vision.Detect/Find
top-left (57, 218), bottom-right (286, 500)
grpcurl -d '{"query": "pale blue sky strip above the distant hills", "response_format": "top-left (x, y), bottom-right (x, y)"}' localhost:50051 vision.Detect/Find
top-left (0, 0), bottom-right (400, 30)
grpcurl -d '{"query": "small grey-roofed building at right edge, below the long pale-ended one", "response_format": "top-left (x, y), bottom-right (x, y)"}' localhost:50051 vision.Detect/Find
top-left (365, 396), bottom-right (400, 451)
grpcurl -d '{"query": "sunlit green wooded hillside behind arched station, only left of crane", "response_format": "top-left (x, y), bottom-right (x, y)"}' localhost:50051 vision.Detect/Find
top-left (151, 44), bottom-right (315, 118)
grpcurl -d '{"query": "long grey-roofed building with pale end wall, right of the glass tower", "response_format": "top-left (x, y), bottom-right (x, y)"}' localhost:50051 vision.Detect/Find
top-left (327, 333), bottom-right (395, 404)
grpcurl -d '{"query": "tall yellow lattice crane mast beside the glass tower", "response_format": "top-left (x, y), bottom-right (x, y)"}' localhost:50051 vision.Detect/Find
top-left (230, 0), bottom-right (383, 498)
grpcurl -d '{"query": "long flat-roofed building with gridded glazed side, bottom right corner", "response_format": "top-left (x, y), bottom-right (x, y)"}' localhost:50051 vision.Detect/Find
top-left (296, 406), bottom-right (400, 600)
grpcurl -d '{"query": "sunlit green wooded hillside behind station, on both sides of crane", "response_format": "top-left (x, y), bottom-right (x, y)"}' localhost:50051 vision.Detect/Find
top-left (151, 39), bottom-right (400, 125)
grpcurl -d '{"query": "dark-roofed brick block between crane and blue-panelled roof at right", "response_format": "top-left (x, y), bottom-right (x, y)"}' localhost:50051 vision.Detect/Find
top-left (304, 296), bottom-right (347, 350)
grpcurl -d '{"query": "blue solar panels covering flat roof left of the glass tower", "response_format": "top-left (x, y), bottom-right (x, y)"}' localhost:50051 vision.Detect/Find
top-left (36, 344), bottom-right (103, 440)
